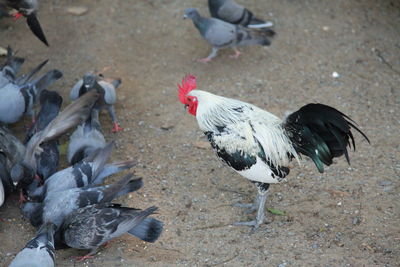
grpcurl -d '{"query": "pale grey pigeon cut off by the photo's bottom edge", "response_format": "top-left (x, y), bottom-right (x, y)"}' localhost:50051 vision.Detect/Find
top-left (9, 223), bottom-right (55, 267)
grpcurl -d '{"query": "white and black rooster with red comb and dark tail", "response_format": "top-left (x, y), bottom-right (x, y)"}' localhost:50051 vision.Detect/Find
top-left (178, 75), bottom-right (369, 229)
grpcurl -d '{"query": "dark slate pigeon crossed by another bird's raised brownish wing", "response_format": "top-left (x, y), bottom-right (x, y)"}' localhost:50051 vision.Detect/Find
top-left (24, 90), bottom-right (63, 181)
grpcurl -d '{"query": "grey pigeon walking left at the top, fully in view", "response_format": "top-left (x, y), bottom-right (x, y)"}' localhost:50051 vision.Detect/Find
top-left (184, 8), bottom-right (271, 63)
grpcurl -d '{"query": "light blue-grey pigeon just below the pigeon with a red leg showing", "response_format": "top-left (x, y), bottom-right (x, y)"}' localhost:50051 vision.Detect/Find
top-left (67, 113), bottom-right (106, 165)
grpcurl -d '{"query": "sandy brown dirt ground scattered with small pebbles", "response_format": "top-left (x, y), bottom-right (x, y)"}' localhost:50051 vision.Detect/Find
top-left (0, 0), bottom-right (400, 267)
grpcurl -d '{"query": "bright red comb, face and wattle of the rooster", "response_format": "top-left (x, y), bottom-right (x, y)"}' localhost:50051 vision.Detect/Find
top-left (178, 74), bottom-right (199, 116)
